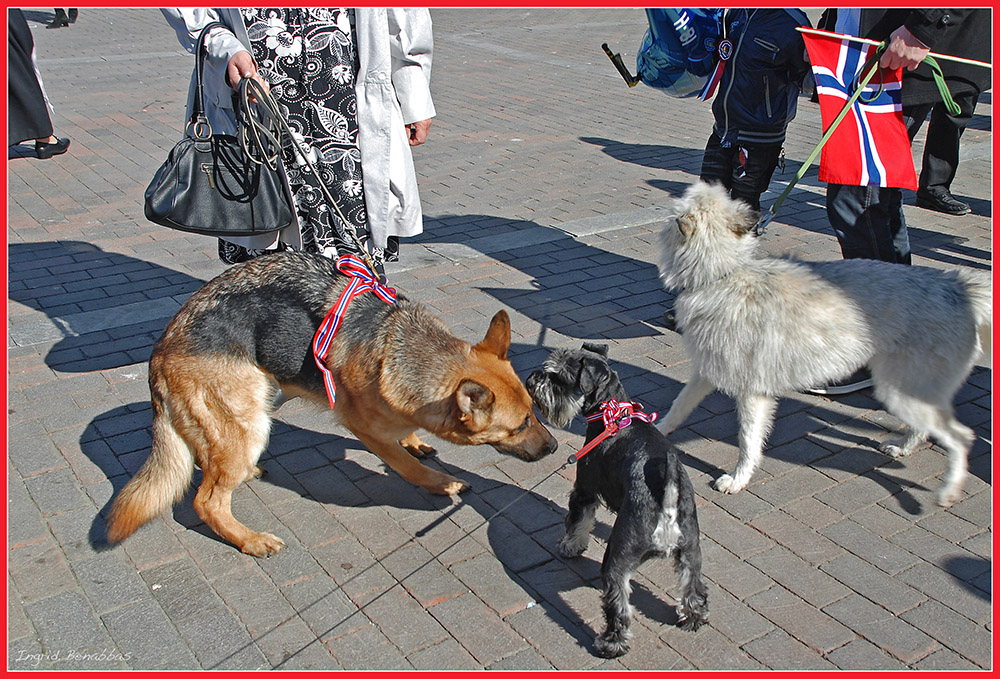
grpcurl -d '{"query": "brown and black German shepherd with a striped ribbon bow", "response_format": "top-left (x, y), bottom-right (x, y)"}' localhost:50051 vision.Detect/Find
top-left (107, 253), bottom-right (557, 556)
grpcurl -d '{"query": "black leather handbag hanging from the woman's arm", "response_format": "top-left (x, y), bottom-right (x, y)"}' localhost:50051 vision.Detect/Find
top-left (145, 22), bottom-right (295, 237)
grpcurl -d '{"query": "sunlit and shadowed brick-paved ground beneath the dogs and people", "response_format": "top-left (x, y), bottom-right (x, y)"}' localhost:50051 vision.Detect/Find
top-left (7, 8), bottom-right (993, 670)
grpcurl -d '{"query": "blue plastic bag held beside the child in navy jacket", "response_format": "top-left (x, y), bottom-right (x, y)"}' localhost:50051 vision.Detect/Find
top-left (636, 8), bottom-right (722, 97)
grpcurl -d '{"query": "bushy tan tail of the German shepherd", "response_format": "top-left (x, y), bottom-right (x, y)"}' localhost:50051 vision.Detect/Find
top-left (107, 396), bottom-right (194, 543)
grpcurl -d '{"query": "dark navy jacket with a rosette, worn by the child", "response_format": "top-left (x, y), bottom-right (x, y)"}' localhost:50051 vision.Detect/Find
top-left (712, 8), bottom-right (810, 146)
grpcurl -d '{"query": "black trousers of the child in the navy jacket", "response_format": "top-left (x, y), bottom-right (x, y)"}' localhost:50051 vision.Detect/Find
top-left (701, 132), bottom-right (781, 210)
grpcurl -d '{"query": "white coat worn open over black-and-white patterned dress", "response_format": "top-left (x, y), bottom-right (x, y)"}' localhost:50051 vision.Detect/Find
top-left (161, 7), bottom-right (436, 249)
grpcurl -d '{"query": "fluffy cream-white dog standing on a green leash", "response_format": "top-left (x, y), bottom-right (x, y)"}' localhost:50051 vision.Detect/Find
top-left (658, 183), bottom-right (992, 506)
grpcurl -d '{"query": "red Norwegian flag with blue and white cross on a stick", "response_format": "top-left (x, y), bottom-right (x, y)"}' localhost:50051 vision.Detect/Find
top-left (803, 32), bottom-right (917, 189)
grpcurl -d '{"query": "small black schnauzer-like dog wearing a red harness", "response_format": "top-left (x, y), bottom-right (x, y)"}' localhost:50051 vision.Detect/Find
top-left (526, 343), bottom-right (708, 658)
